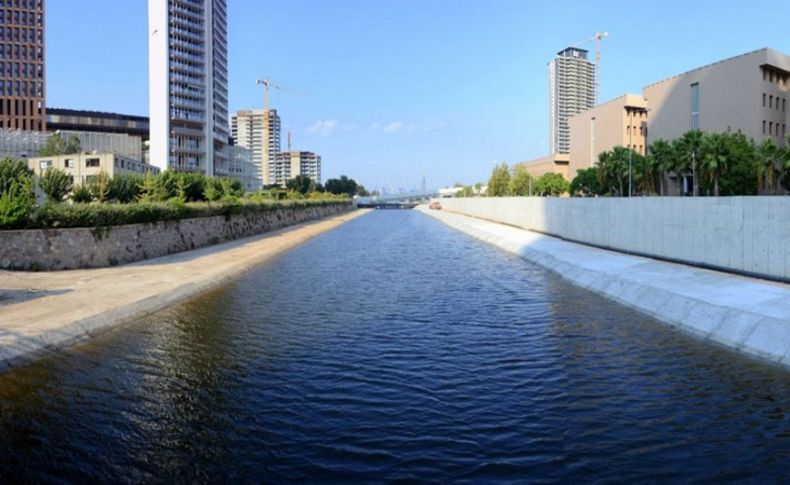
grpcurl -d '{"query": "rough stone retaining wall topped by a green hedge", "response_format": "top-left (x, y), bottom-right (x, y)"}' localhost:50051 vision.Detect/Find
top-left (0, 203), bottom-right (353, 271)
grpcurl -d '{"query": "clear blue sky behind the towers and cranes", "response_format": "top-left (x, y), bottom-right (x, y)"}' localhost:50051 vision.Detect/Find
top-left (47, 0), bottom-right (790, 189)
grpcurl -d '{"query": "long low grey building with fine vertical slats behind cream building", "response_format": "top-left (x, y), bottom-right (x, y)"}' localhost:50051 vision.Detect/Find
top-left (0, 129), bottom-right (144, 161)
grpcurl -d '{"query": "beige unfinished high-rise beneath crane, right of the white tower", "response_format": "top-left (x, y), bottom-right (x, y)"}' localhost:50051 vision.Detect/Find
top-left (230, 109), bottom-right (280, 185)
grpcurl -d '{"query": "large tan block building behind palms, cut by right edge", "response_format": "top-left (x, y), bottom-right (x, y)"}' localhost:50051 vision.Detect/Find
top-left (643, 48), bottom-right (790, 147)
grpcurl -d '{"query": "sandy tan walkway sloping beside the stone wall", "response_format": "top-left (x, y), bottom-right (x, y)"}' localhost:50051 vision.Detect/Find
top-left (0, 210), bottom-right (367, 370)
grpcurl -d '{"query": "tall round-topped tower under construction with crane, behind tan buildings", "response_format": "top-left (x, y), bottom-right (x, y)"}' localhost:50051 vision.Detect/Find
top-left (549, 47), bottom-right (595, 153)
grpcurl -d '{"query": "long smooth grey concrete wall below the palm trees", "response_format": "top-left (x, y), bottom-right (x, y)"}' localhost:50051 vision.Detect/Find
top-left (441, 197), bottom-right (790, 281)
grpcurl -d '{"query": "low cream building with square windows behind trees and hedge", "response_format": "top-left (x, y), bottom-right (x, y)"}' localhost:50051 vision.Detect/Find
top-left (27, 153), bottom-right (159, 185)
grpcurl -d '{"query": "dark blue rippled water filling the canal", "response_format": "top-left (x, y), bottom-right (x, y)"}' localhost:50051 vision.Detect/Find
top-left (0, 211), bottom-right (790, 483)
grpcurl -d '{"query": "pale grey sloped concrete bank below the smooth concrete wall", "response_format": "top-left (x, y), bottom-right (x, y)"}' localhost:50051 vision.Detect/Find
top-left (424, 208), bottom-right (790, 368)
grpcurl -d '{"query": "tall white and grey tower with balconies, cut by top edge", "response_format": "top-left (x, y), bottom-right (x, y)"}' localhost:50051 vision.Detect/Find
top-left (148, 0), bottom-right (229, 176)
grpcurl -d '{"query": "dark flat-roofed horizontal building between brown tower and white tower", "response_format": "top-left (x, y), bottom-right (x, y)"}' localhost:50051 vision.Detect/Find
top-left (46, 108), bottom-right (150, 141)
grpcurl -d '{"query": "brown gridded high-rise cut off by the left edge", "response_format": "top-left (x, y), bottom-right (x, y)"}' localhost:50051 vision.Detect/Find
top-left (0, 0), bottom-right (46, 131)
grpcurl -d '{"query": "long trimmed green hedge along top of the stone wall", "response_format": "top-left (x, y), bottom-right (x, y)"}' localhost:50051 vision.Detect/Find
top-left (17, 199), bottom-right (351, 229)
